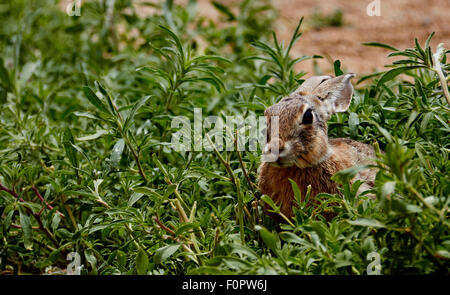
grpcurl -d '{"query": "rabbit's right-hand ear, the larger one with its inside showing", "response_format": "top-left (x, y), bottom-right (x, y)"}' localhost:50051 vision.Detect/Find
top-left (312, 74), bottom-right (355, 116)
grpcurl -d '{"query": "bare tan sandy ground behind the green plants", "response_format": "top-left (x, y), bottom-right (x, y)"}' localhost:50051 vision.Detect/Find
top-left (61, 0), bottom-right (450, 75)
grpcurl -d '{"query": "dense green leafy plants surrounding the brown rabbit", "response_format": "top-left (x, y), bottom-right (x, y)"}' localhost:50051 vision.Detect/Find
top-left (0, 0), bottom-right (450, 274)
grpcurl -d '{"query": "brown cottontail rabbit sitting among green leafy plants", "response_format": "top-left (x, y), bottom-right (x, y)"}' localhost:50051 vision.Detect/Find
top-left (259, 74), bottom-right (376, 217)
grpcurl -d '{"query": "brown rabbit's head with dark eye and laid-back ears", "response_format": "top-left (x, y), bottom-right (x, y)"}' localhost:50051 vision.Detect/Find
top-left (263, 74), bottom-right (355, 168)
